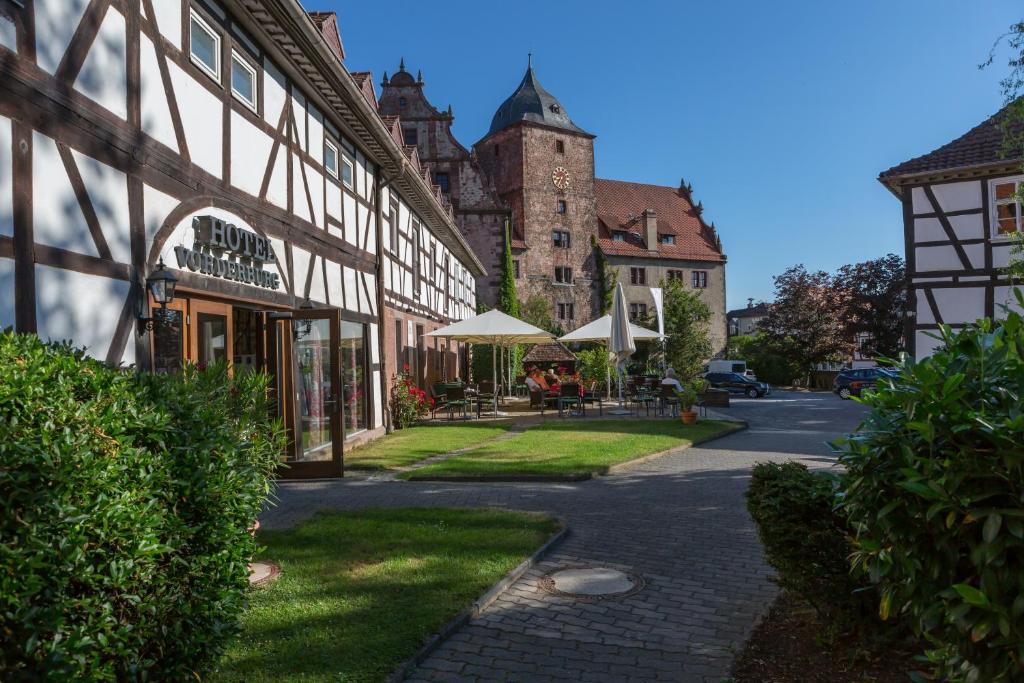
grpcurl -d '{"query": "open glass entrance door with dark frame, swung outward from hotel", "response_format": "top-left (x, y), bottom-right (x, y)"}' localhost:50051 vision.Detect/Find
top-left (274, 309), bottom-right (343, 477)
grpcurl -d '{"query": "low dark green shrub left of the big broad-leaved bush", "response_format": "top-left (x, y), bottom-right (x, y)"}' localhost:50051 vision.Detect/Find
top-left (746, 462), bottom-right (871, 628)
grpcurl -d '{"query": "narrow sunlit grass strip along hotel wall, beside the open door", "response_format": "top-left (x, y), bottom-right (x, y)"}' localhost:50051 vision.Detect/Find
top-left (345, 422), bottom-right (520, 470)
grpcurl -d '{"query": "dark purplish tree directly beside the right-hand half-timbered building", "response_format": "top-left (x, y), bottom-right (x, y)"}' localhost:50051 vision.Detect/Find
top-left (836, 254), bottom-right (906, 358)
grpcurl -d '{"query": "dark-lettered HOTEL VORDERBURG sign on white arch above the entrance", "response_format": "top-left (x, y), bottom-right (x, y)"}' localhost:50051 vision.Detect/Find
top-left (174, 216), bottom-right (281, 290)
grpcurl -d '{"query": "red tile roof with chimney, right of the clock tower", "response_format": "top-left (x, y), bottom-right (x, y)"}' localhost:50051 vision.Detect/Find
top-left (594, 178), bottom-right (725, 262)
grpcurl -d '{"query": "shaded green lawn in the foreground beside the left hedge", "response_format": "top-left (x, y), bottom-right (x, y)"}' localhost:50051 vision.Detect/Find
top-left (212, 508), bottom-right (558, 683)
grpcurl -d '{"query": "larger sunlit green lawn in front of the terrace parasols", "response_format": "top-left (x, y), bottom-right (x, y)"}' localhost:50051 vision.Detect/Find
top-left (401, 420), bottom-right (737, 479)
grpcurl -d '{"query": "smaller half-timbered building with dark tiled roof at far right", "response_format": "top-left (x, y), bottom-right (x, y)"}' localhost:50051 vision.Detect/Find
top-left (879, 105), bottom-right (1024, 357)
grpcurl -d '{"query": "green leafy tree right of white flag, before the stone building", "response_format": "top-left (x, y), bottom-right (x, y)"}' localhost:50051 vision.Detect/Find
top-left (662, 280), bottom-right (712, 380)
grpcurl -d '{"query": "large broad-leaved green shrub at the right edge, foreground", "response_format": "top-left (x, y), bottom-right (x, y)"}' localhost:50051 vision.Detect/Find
top-left (840, 311), bottom-right (1024, 683)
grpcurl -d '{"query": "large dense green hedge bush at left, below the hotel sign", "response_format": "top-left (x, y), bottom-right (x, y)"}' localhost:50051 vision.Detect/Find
top-left (0, 332), bottom-right (284, 681)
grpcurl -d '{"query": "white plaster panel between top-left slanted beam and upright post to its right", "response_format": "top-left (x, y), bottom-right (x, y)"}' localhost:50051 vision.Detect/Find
top-left (75, 8), bottom-right (128, 119)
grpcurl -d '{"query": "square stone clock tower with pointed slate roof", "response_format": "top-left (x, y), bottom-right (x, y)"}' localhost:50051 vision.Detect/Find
top-left (474, 65), bottom-right (599, 331)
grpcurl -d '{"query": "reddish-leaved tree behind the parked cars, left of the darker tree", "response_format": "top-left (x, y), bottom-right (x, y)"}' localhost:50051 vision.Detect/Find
top-left (761, 264), bottom-right (853, 377)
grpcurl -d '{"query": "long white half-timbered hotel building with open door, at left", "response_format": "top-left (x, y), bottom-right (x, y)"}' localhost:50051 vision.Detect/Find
top-left (0, 0), bottom-right (483, 476)
